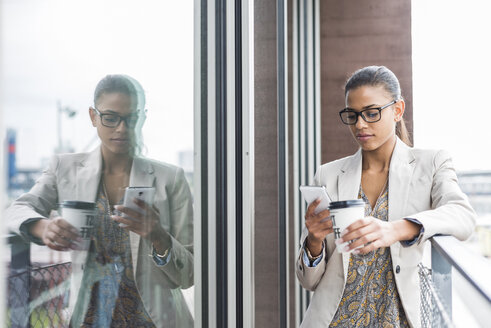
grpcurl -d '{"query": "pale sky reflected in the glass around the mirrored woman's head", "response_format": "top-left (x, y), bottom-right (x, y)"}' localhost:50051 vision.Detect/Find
top-left (0, 0), bottom-right (194, 168)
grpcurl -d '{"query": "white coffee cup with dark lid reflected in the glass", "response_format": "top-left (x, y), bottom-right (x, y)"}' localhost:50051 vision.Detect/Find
top-left (60, 200), bottom-right (97, 250)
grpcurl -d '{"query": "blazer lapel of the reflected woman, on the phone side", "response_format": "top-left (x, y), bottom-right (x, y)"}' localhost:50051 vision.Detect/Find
top-left (129, 157), bottom-right (155, 275)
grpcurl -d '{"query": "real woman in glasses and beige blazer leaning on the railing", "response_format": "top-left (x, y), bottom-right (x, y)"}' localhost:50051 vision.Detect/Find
top-left (296, 66), bottom-right (475, 327)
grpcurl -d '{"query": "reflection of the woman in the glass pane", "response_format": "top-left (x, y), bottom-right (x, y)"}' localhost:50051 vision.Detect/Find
top-left (7, 75), bottom-right (193, 327)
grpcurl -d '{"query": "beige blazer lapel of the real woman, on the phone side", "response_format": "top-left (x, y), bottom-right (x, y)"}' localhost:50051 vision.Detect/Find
top-left (338, 148), bottom-right (362, 280)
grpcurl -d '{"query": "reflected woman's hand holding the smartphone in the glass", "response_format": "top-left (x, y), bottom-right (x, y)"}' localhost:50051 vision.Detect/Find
top-left (111, 198), bottom-right (171, 250)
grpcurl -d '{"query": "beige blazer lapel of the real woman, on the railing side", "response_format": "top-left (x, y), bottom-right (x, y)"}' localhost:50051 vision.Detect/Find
top-left (388, 138), bottom-right (416, 259)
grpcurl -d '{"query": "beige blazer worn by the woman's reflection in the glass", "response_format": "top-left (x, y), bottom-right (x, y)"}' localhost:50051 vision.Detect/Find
top-left (6, 148), bottom-right (194, 327)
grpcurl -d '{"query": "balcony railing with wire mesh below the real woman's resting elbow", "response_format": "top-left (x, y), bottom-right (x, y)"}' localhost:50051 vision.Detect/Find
top-left (420, 236), bottom-right (491, 328)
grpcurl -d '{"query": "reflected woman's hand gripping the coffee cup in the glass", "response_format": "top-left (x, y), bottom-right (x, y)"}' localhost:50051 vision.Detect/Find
top-left (30, 216), bottom-right (82, 251)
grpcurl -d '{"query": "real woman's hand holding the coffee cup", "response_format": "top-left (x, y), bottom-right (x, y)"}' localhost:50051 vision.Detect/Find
top-left (337, 216), bottom-right (419, 254)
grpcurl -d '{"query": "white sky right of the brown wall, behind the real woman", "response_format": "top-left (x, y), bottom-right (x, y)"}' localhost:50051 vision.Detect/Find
top-left (412, 0), bottom-right (491, 171)
